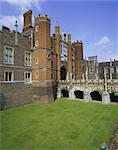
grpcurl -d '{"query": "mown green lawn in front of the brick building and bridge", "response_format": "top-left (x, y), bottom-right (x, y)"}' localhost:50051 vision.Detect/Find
top-left (0, 99), bottom-right (118, 150)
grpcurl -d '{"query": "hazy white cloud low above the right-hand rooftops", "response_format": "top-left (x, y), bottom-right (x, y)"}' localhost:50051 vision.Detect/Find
top-left (87, 36), bottom-right (118, 61)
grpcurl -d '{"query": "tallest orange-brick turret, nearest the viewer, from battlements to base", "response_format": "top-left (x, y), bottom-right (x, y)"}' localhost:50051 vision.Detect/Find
top-left (32, 15), bottom-right (54, 102)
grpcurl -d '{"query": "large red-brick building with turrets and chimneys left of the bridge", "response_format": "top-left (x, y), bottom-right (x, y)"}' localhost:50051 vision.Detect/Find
top-left (0, 10), bottom-right (83, 109)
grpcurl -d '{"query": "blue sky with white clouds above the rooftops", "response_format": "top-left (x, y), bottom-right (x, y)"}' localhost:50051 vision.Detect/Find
top-left (0, 0), bottom-right (118, 61)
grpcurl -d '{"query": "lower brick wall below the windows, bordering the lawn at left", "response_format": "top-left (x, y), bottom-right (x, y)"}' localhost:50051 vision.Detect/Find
top-left (0, 82), bottom-right (57, 109)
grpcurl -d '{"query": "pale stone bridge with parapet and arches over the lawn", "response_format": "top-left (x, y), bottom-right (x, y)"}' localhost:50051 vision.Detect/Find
top-left (57, 79), bottom-right (118, 104)
